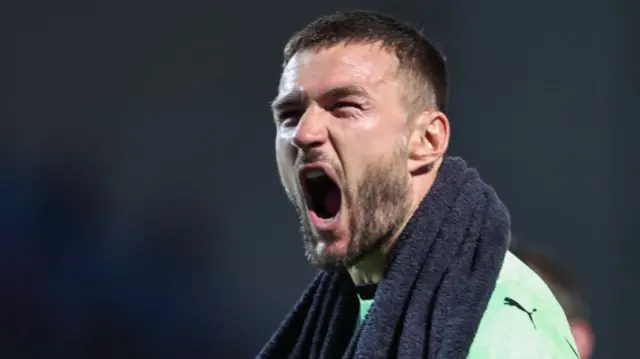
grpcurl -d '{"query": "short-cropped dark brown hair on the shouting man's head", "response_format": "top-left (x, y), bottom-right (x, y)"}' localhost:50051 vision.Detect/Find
top-left (284, 11), bottom-right (449, 111)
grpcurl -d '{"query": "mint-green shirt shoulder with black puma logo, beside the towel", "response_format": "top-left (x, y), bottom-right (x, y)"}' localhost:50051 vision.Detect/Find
top-left (469, 253), bottom-right (578, 359)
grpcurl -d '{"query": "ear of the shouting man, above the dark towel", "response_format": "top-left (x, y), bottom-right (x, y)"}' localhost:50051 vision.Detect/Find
top-left (409, 111), bottom-right (449, 172)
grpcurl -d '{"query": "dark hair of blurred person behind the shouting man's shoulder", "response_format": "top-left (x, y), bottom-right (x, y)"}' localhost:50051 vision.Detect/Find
top-left (511, 243), bottom-right (589, 320)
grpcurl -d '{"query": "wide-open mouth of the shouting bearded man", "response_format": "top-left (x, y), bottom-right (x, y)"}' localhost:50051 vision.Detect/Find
top-left (300, 168), bottom-right (342, 220)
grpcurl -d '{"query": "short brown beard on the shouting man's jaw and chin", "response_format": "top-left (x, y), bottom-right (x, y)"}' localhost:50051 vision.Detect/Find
top-left (296, 146), bottom-right (411, 270)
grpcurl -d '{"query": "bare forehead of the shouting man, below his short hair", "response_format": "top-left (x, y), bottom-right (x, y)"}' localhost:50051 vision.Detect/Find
top-left (279, 44), bottom-right (398, 94)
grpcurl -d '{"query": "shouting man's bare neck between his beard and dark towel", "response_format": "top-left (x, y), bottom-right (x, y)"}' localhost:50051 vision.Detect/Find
top-left (348, 160), bottom-right (442, 285)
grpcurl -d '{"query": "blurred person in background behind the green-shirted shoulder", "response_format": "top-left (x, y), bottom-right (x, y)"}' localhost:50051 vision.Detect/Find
top-left (513, 243), bottom-right (595, 359)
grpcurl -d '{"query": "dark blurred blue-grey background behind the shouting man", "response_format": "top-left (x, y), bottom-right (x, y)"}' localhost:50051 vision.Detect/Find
top-left (0, 0), bottom-right (640, 359)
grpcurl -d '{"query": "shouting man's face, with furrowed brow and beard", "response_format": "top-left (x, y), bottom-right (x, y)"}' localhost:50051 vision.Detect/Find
top-left (273, 44), bottom-right (411, 269)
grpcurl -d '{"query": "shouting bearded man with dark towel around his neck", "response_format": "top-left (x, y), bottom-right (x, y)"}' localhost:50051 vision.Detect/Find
top-left (258, 11), bottom-right (578, 359)
